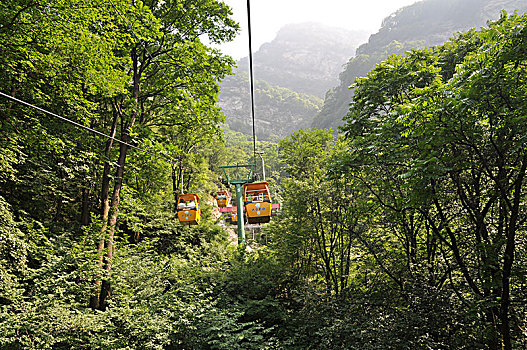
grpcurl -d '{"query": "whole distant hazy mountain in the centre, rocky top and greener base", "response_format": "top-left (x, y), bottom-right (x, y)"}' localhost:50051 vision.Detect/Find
top-left (219, 23), bottom-right (367, 140)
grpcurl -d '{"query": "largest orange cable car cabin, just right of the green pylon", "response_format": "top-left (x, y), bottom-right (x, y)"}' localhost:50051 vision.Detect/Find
top-left (243, 182), bottom-right (271, 224)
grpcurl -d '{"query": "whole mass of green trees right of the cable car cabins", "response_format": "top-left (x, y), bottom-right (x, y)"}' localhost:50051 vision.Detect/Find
top-left (273, 15), bottom-right (527, 349)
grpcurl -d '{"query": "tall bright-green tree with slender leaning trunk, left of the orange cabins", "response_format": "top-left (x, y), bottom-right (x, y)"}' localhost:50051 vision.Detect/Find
top-left (91, 1), bottom-right (237, 309)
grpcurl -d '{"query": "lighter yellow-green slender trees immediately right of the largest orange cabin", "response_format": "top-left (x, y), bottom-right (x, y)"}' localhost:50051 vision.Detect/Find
top-left (271, 130), bottom-right (368, 297)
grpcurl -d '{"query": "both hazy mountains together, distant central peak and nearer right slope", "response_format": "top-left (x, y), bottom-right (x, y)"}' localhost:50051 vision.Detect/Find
top-left (219, 0), bottom-right (527, 140)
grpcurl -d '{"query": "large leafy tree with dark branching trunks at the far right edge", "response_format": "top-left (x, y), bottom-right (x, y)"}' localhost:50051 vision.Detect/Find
top-left (345, 15), bottom-right (526, 349)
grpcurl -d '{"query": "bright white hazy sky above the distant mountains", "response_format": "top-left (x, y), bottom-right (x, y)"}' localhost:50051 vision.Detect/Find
top-left (217, 0), bottom-right (417, 59)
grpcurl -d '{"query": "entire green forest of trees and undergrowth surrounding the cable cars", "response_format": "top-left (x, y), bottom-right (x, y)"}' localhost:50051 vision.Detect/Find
top-left (0, 0), bottom-right (527, 350)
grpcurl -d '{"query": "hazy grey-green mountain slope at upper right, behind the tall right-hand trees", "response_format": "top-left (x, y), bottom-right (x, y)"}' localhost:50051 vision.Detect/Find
top-left (312, 0), bottom-right (527, 129)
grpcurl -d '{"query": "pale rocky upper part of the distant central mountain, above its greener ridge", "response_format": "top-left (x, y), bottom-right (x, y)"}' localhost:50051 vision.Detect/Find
top-left (237, 22), bottom-right (368, 98)
